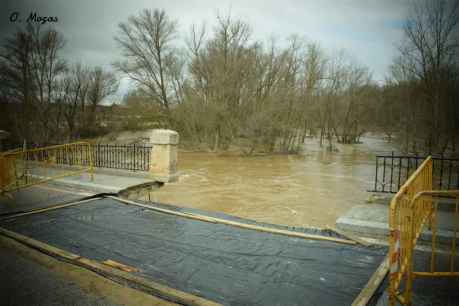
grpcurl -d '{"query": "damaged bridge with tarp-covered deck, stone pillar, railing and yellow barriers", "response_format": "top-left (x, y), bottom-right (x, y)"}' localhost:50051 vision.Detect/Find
top-left (0, 130), bottom-right (459, 305)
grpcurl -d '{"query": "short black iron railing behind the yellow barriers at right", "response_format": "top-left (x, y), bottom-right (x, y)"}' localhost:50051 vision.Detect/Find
top-left (371, 152), bottom-right (459, 193)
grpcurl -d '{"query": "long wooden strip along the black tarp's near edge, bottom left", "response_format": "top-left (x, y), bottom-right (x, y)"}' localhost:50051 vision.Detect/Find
top-left (0, 227), bottom-right (220, 306)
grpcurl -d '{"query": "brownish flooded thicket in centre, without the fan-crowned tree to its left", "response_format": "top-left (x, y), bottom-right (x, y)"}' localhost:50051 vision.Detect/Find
top-left (174, 16), bottom-right (380, 154)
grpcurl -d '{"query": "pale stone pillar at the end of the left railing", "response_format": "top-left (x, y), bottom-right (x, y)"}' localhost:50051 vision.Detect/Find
top-left (150, 129), bottom-right (179, 183)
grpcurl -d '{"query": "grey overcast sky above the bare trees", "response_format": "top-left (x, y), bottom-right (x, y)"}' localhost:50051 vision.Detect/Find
top-left (0, 0), bottom-right (409, 100)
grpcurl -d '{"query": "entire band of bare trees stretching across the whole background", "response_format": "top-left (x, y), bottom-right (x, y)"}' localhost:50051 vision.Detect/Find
top-left (1, 0), bottom-right (459, 154)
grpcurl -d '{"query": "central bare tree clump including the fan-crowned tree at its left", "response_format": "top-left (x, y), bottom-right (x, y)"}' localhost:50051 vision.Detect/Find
top-left (116, 10), bottom-right (375, 153)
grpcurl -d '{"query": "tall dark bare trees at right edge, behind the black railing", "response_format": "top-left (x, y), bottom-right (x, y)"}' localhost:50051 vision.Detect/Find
top-left (383, 0), bottom-right (459, 152)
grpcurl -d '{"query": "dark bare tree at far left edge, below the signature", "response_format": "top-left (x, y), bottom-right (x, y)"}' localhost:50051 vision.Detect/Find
top-left (0, 24), bottom-right (65, 142)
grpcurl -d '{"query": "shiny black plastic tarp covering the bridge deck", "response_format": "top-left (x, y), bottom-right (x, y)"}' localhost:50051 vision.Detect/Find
top-left (0, 198), bottom-right (386, 305)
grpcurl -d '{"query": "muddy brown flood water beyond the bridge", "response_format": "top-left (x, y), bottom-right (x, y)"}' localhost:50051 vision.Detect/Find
top-left (151, 137), bottom-right (393, 227)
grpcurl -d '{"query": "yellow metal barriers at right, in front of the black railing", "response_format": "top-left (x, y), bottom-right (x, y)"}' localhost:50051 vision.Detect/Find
top-left (389, 157), bottom-right (459, 305)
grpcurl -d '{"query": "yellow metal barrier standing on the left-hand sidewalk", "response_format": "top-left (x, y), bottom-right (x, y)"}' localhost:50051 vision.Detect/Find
top-left (0, 142), bottom-right (93, 194)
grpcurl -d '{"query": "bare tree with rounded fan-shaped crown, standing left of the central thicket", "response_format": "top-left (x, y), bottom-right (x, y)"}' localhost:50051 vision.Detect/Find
top-left (115, 9), bottom-right (180, 112)
